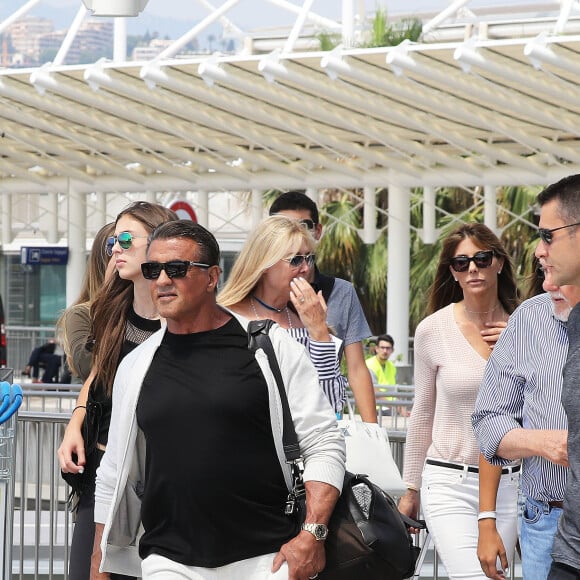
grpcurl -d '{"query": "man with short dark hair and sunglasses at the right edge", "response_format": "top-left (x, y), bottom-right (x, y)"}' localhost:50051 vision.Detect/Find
top-left (535, 174), bottom-right (580, 580)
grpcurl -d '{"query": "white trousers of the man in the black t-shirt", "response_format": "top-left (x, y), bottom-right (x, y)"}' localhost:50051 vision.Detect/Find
top-left (141, 554), bottom-right (288, 580)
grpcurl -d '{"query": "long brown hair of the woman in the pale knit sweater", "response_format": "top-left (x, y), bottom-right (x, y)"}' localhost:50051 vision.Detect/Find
top-left (428, 223), bottom-right (520, 314)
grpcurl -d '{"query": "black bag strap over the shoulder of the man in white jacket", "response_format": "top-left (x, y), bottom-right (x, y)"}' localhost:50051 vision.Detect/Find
top-left (248, 319), bottom-right (301, 462)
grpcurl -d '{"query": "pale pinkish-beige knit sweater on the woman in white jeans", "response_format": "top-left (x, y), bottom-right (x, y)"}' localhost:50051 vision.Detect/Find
top-left (403, 304), bottom-right (486, 489)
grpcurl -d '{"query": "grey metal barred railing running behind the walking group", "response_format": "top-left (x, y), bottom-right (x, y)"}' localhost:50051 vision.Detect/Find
top-left (7, 385), bottom-right (518, 580)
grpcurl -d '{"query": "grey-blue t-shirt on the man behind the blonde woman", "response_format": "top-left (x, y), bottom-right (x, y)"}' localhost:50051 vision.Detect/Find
top-left (326, 278), bottom-right (372, 346)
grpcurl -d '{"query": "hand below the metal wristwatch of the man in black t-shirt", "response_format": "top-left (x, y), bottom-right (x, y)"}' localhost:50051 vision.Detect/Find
top-left (274, 531), bottom-right (326, 580)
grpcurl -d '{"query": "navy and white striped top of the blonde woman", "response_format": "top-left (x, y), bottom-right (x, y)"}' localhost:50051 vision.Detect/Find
top-left (286, 328), bottom-right (348, 413)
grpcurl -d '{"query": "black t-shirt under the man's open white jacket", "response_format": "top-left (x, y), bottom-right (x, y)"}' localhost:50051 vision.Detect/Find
top-left (137, 318), bottom-right (294, 568)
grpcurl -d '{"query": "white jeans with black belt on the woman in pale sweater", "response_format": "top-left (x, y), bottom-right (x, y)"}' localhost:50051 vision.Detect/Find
top-left (421, 464), bottom-right (520, 580)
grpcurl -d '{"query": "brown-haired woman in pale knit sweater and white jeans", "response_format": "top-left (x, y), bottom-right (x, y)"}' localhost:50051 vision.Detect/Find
top-left (399, 224), bottom-right (519, 580)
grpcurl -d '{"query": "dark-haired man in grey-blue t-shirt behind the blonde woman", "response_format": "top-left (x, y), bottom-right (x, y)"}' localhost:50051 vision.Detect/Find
top-left (269, 191), bottom-right (377, 423)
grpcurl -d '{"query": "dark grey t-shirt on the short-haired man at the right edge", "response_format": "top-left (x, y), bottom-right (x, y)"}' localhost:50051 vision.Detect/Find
top-left (552, 304), bottom-right (580, 570)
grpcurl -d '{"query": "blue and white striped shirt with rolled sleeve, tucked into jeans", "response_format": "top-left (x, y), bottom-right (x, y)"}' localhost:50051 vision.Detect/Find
top-left (472, 294), bottom-right (568, 502)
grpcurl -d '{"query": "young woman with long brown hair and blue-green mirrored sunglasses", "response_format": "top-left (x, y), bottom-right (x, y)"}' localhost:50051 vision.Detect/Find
top-left (58, 201), bottom-right (178, 580)
